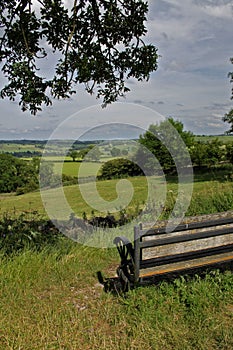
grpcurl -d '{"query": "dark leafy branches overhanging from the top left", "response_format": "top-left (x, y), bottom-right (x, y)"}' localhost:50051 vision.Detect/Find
top-left (0, 0), bottom-right (158, 114)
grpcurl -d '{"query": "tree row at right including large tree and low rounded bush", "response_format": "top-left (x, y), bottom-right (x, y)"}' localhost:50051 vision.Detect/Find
top-left (99, 118), bottom-right (233, 179)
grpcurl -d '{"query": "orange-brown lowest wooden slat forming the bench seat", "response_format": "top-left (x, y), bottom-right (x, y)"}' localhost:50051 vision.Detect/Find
top-left (139, 251), bottom-right (233, 278)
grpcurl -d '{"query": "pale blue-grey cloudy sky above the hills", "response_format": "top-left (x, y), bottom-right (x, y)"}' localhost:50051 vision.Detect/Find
top-left (0, 0), bottom-right (233, 140)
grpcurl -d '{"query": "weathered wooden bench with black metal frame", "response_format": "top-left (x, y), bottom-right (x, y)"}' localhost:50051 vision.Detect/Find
top-left (114, 212), bottom-right (233, 291)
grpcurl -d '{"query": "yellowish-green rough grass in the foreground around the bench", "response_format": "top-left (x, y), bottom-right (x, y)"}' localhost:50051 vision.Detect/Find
top-left (0, 240), bottom-right (233, 350)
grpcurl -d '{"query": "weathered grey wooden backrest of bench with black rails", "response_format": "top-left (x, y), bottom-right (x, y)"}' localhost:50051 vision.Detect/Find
top-left (134, 216), bottom-right (233, 280)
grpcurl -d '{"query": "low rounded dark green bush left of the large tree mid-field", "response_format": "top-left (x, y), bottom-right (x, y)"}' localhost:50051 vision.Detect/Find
top-left (98, 158), bottom-right (143, 180)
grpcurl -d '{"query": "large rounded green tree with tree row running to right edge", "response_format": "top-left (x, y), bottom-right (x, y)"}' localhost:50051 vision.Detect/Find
top-left (136, 118), bottom-right (233, 172)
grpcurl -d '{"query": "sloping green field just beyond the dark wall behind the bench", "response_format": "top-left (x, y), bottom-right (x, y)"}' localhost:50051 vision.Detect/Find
top-left (0, 175), bottom-right (233, 217)
